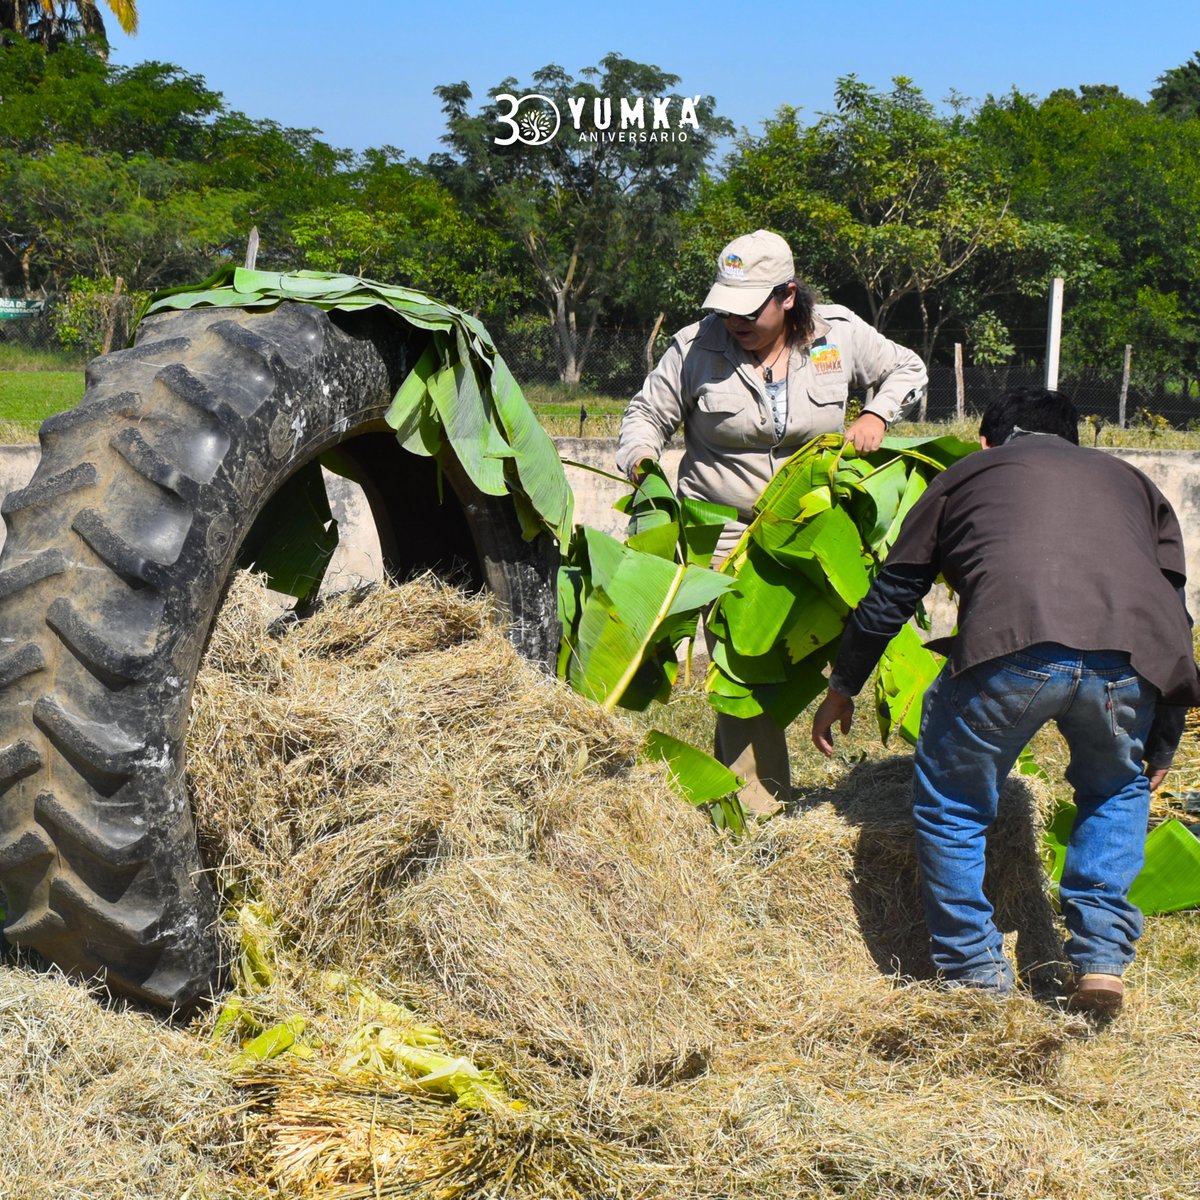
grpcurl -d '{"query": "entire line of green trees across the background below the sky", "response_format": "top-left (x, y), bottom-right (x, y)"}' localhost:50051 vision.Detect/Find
top-left (0, 36), bottom-right (1200, 383)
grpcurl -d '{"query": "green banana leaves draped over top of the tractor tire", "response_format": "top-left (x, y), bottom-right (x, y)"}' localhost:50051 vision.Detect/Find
top-left (139, 266), bottom-right (575, 545)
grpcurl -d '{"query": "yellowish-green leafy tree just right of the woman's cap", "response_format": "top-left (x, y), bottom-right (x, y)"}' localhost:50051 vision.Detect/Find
top-left (710, 76), bottom-right (1060, 359)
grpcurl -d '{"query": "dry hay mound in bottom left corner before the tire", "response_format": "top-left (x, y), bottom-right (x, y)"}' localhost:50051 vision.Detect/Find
top-left (0, 966), bottom-right (248, 1200)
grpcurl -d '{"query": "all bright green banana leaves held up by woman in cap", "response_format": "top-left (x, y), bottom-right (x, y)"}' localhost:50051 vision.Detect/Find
top-left (559, 434), bottom-right (977, 738)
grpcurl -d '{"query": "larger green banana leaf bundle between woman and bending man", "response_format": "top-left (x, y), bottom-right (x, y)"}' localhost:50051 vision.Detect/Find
top-left (704, 434), bottom-right (977, 724)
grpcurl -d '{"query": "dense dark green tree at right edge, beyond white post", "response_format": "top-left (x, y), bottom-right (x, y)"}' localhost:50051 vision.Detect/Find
top-left (974, 85), bottom-right (1200, 378)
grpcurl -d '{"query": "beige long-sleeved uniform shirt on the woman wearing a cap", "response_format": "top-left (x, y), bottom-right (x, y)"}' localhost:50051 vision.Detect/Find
top-left (617, 305), bottom-right (928, 522)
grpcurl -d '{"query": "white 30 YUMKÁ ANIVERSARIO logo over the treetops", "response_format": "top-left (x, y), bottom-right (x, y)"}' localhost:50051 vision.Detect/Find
top-left (492, 91), bottom-right (700, 146)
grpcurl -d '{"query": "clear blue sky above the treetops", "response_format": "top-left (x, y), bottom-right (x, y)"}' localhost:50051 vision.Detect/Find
top-left (107, 0), bottom-right (1200, 158)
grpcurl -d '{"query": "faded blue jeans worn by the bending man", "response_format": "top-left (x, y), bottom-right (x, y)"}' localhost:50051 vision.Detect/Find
top-left (913, 642), bottom-right (1158, 991)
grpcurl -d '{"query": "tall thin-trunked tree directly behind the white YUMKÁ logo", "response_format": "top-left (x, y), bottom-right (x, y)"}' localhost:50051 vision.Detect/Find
top-left (430, 54), bottom-right (732, 384)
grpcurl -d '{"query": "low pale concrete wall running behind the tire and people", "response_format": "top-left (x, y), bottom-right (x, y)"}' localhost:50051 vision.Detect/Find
top-left (0, 438), bottom-right (1200, 624)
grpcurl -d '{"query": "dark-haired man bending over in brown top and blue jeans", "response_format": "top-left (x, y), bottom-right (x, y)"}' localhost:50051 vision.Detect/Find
top-left (812, 388), bottom-right (1200, 1015)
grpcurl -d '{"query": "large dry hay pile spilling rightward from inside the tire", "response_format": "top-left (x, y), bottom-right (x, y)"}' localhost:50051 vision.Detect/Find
top-left (0, 581), bottom-right (1200, 1200)
